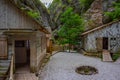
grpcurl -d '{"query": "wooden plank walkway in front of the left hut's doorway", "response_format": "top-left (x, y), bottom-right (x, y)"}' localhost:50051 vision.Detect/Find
top-left (15, 66), bottom-right (38, 80)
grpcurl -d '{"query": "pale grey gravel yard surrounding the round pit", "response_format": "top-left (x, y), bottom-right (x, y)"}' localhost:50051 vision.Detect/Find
top-left (39, 52), bottom-right (120, 80)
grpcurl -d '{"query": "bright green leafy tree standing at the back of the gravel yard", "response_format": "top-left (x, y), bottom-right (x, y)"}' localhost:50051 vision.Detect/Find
top-left (57, 7), bottom-right (84, 51)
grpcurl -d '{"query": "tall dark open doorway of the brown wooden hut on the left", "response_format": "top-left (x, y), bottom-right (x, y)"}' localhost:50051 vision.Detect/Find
top-left (15, 40), bottom-right (30, 68)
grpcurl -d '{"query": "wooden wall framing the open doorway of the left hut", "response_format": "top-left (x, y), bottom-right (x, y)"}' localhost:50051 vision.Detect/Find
top-left (5, 33), bottom-right (37, 72)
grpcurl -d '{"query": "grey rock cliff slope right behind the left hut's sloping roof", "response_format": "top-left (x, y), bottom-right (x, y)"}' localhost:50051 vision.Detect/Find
top-left (11, 0), bottom-right (54, 31)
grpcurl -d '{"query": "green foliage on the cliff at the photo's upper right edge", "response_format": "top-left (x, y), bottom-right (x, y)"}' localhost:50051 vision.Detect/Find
top-left (105, 3), bottom-right (120, 20)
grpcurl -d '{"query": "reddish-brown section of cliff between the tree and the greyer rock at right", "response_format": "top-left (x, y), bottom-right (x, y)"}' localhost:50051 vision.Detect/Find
top-left (84, 0), bottom-right (103, 30)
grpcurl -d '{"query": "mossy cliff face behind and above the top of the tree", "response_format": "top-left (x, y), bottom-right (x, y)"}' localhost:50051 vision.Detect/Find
top-left (49, 0), bottom-right (94, 30)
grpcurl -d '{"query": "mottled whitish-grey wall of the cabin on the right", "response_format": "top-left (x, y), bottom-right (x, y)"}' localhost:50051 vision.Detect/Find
top-left (84, 22), bottom-right (120, 52)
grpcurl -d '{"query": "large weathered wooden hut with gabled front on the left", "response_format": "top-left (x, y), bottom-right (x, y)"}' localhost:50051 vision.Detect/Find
top-left (0, 0), bottom-right (49, 72)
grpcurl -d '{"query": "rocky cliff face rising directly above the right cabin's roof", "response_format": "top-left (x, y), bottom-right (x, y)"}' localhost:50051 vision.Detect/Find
top-left (84, 0), bottom-right (119, 30)
